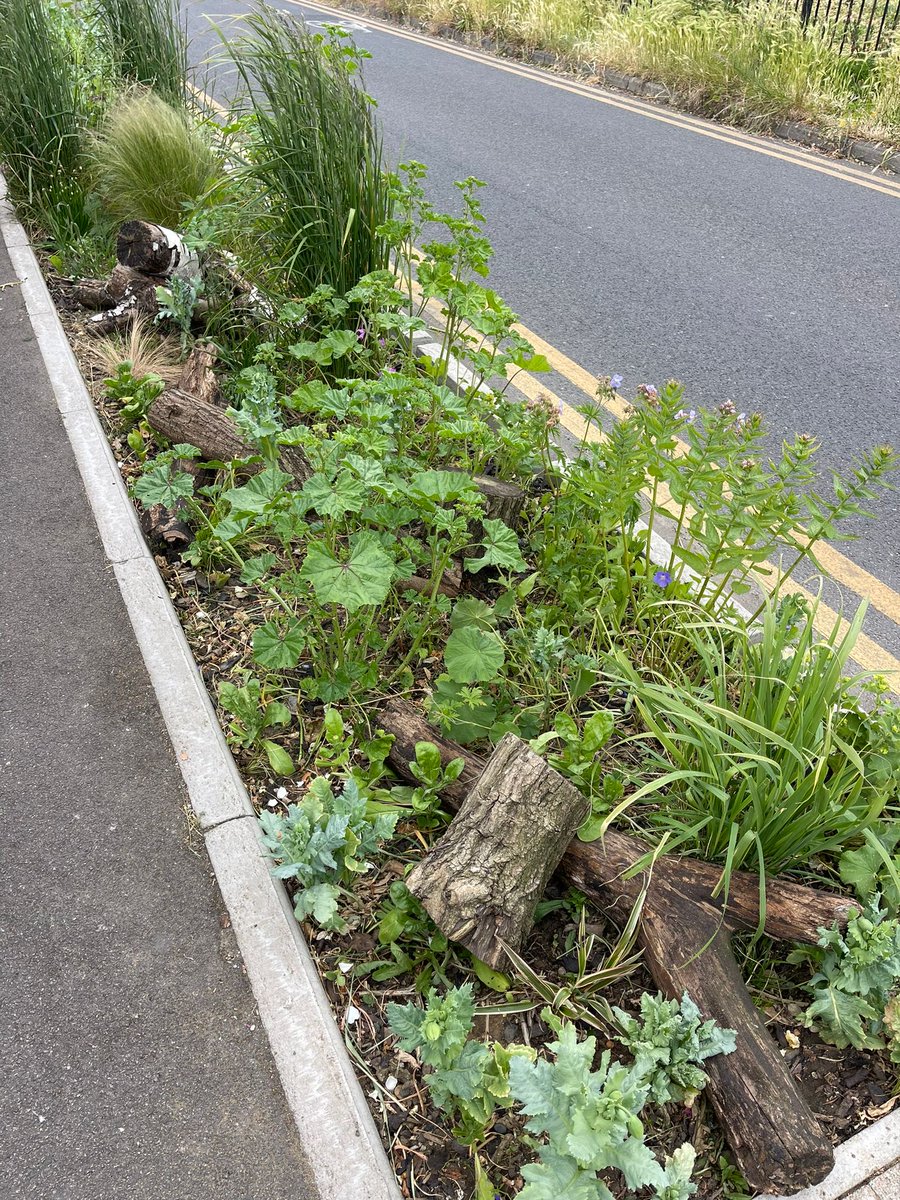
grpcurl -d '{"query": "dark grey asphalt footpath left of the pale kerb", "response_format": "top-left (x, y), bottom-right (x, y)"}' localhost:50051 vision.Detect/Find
top-left (0, 226), bottom-right (319, 1200)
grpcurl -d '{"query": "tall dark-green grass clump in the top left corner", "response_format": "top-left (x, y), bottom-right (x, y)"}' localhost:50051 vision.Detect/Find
top-left (0, 0), bottom-right (92, 240)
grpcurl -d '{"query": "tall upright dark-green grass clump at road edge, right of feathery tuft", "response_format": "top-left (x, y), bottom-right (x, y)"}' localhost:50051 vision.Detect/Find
top-left (228, 6), bottom-right (390, 292)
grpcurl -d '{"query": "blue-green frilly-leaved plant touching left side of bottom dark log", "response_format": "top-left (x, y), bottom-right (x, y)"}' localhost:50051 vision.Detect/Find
top-left (613, 991), bottom-right (736, 1106)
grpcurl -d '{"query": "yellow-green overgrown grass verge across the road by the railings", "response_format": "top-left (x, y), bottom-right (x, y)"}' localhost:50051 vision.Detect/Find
top-left (389, 0), bottom-right (900, 142)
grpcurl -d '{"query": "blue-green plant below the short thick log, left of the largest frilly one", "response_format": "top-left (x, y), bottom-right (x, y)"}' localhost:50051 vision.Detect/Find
top-left (388, 984), bottom-right (535, 1145)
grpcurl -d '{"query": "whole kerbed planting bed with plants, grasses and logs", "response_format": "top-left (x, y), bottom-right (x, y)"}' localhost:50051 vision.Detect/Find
top-left (0, 0), bottom-right (900, 1200)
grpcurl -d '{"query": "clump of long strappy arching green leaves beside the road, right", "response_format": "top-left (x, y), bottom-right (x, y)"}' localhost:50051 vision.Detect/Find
top-left (606, 592), bottom-right (893, 892)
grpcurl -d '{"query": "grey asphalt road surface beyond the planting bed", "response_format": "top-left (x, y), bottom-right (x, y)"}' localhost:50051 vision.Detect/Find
top-left (185, 0), bottom-right (900, 654)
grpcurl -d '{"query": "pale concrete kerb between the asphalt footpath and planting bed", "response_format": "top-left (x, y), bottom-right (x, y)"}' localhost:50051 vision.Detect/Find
top-left (0, 174), bottom-right (401, 1200)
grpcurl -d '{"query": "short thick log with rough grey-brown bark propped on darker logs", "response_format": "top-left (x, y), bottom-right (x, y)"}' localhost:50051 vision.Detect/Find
top-left (407, 733), bottom-right (590, 967)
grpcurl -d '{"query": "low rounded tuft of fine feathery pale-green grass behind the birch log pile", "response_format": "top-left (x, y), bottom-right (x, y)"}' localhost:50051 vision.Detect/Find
top-left (91, 91), bottom-right (217, 229)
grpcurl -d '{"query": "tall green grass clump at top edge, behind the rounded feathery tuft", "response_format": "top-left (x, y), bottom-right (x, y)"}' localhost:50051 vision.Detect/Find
top-left (97, 0), bottom-right (187, 104)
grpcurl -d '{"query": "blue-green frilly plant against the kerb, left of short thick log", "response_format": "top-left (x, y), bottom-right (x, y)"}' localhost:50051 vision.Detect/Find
top-left (259, 776), bottom-right (397, 931)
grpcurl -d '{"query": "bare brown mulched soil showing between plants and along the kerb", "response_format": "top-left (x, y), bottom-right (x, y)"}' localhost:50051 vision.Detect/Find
top-left (48, 271), bottom-right (900, 1200)
